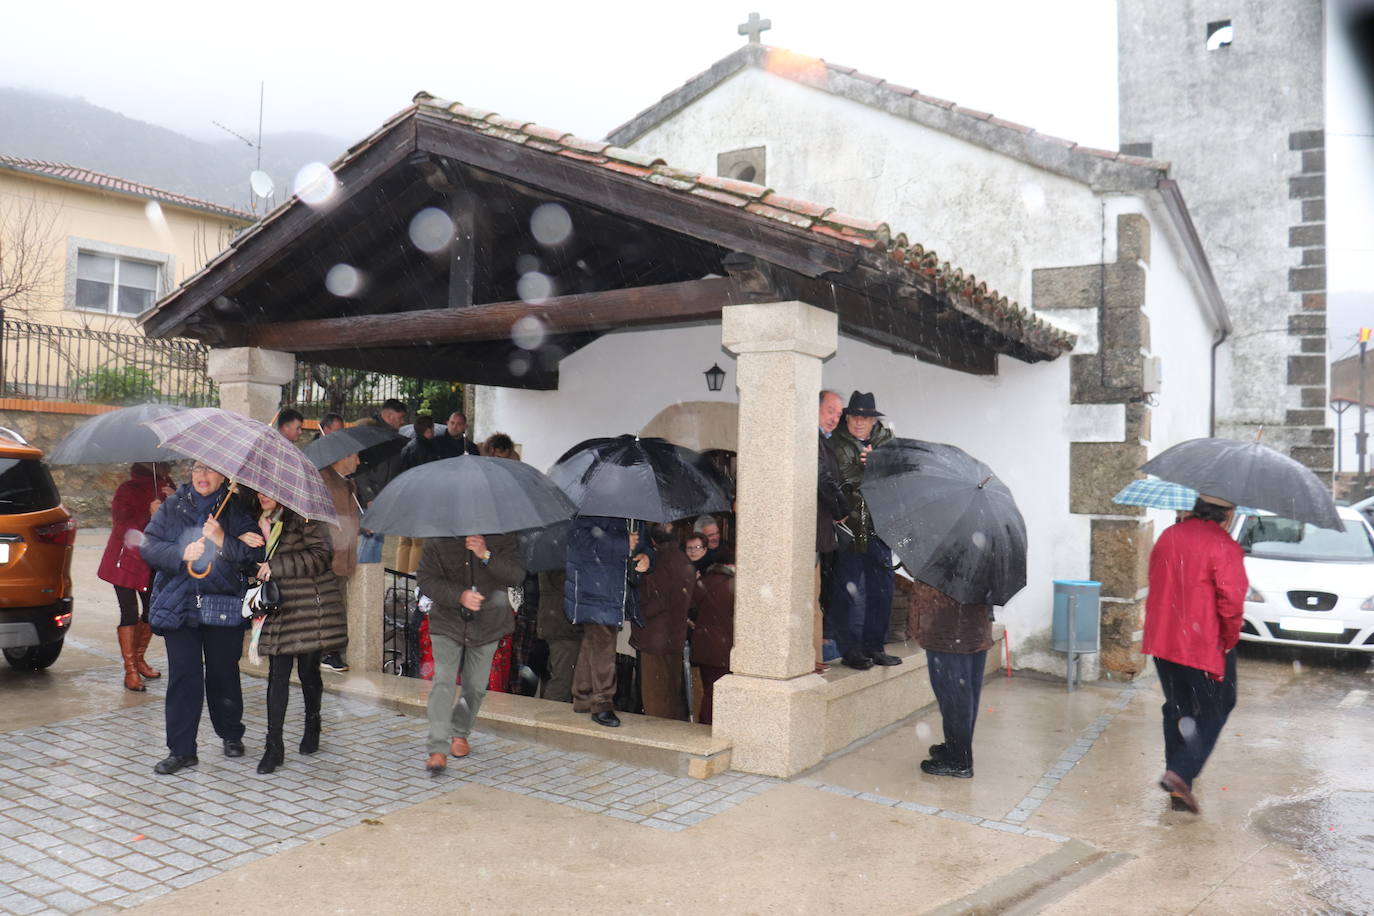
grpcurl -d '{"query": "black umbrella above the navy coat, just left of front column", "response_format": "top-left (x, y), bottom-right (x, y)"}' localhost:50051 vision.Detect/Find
top-left (548, 435), bottom-right (730, 522)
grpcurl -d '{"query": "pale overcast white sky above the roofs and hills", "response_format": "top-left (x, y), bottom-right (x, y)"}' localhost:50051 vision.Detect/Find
top-left (8, 0), bottom-right (1374, 300)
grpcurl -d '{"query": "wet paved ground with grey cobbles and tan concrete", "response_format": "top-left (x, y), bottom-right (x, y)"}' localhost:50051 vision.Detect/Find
top-left (0, 531), bottom-right (1374, 913)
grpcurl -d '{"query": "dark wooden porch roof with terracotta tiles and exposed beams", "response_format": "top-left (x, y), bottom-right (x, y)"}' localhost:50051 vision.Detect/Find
top-left (143, 93), bottom-right (1073, 387)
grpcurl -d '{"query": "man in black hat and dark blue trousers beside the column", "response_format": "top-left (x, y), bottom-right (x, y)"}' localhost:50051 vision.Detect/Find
top-left (827, 391), bottom-right (901, 670)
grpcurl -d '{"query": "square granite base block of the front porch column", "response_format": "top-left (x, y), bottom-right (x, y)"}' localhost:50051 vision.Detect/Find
top-left (712, 674), bottom-right (826, 777)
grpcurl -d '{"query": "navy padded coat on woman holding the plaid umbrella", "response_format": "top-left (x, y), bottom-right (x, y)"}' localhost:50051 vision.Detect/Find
top-left (140, 483), bottom-right (265, 633)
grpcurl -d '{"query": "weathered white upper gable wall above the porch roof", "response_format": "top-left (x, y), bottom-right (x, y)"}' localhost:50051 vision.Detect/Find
top-left (633, 69), bottom-right (1110, 306)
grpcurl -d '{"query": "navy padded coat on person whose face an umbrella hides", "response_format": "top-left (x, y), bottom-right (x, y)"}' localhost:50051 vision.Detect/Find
top-left (563, 515), bottom-right (655, 626)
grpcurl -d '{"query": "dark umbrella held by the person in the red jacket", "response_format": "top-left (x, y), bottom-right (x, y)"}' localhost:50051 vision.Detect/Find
top-left (1140, 438), bottom-right (1345, 531)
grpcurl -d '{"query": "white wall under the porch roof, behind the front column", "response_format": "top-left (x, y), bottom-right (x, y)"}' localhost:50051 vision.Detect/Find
top-left (477, 324), bottom-right (1093, 672)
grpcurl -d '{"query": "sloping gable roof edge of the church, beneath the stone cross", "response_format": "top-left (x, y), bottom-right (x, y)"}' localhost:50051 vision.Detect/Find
top-left (607, 44), bottom-right (1169, 191)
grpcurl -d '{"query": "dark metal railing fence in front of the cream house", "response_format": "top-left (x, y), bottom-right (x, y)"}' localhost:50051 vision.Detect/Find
top-left (0, 312), bottom-right (220, 407)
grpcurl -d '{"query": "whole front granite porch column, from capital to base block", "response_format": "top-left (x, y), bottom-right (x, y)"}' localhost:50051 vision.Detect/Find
top-left (713, 302), bottom-right (838, 776)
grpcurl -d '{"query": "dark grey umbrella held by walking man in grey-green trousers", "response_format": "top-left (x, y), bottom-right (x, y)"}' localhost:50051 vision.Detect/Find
top-left (359, 455), bottom-right (574, 537)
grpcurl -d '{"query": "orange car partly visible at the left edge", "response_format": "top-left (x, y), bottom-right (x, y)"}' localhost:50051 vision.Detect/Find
top-left (0, 427), bottom-right (77, 670)
